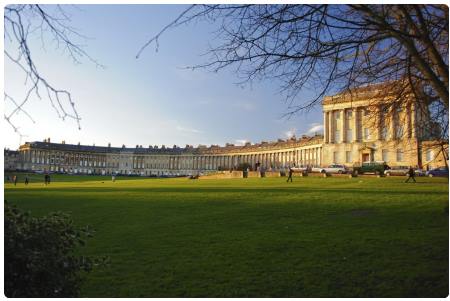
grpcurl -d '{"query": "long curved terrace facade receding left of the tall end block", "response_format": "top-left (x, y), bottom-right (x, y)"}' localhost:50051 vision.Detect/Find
top-left (14, 135), bottom-right (323, 176)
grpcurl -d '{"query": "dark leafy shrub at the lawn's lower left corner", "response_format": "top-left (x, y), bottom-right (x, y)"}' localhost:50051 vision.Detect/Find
top-left (4, 202), bottom-right (106, 298)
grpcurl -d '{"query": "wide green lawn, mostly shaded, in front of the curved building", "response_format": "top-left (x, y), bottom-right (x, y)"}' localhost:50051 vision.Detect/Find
top-left (5, 172), bottom-right (449, 297)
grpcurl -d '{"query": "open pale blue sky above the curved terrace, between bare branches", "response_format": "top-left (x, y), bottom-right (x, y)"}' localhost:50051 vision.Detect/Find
top-left (3, 5), bottom-right (322, 149)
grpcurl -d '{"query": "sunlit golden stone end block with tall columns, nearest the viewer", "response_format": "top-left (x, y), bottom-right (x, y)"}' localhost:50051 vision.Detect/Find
top-left (322, 85), bottom-right (448, 168)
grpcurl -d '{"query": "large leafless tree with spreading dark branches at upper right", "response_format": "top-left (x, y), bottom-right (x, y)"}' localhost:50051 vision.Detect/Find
top-left (137, 4), bottom-right (449, 144)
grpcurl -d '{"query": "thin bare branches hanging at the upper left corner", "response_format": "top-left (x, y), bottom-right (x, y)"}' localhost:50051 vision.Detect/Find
top-left (4, 4), bottom-right (101, 137)
